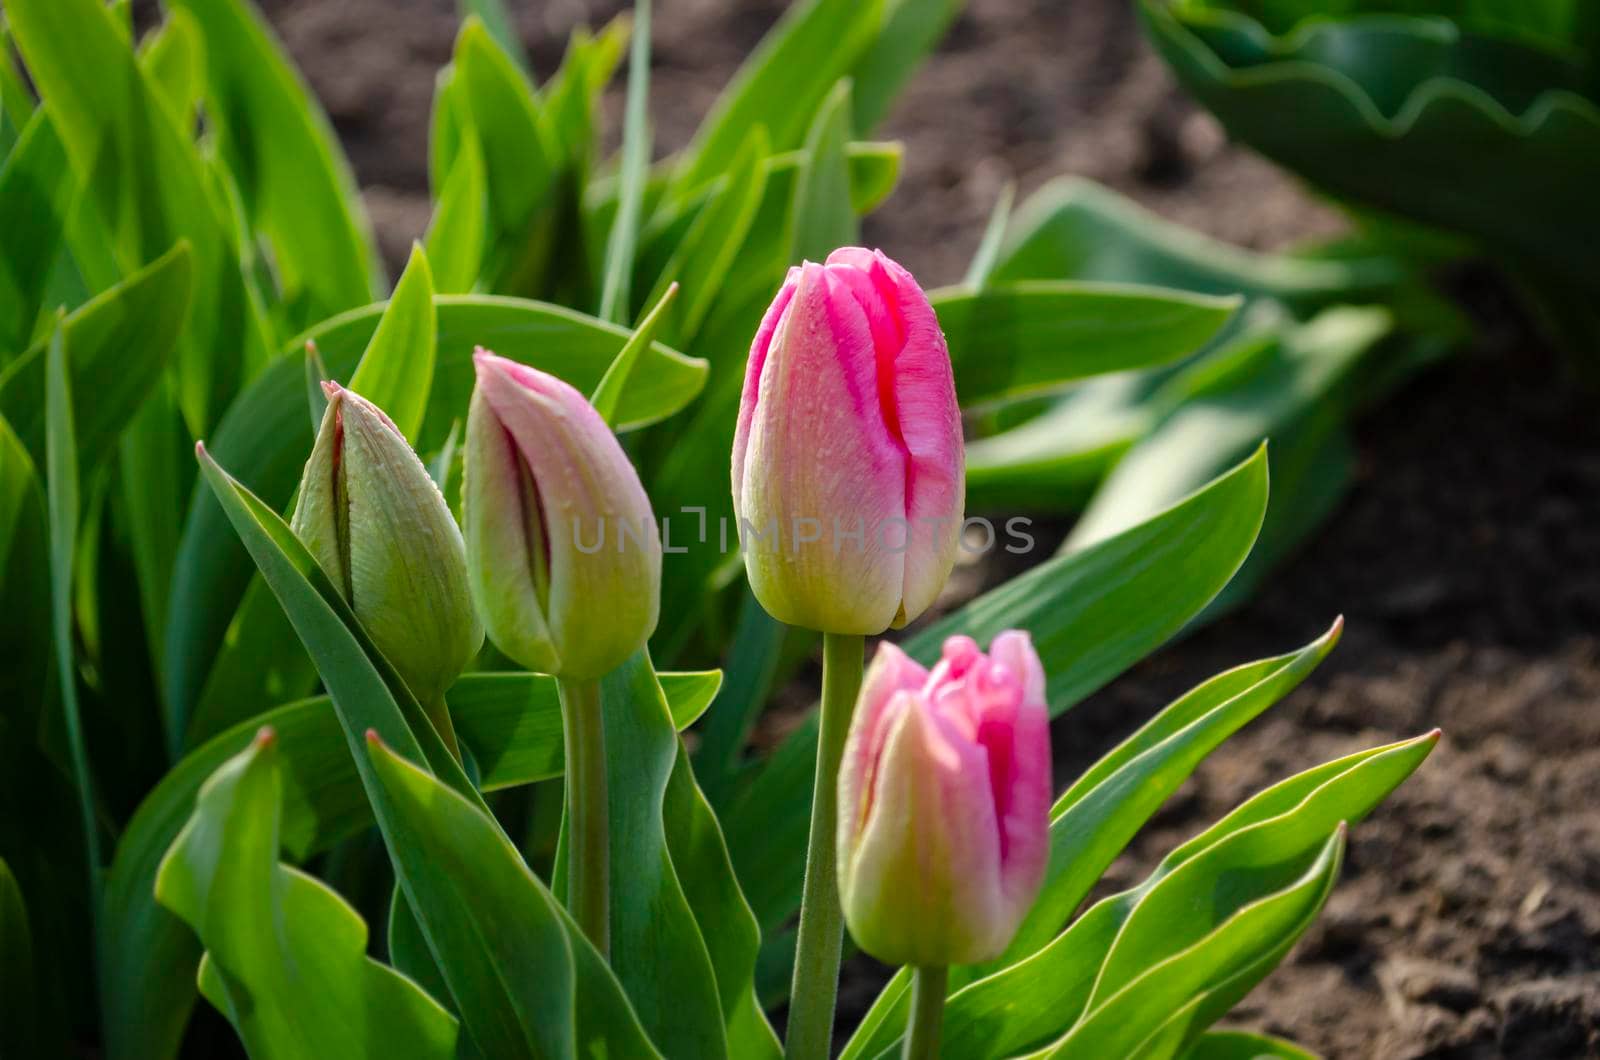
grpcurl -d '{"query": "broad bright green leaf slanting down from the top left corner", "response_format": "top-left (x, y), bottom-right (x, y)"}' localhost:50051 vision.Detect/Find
top-left (6, 0), bottom-right (269, 434)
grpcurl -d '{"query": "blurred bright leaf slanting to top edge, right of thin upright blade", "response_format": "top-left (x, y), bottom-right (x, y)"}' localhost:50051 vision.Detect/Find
top-left (677, 0), bottom-right (883, 195)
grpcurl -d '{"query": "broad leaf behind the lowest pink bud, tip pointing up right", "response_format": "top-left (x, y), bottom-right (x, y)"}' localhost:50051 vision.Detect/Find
top-left (723, 450), bottom-right (1267, 930)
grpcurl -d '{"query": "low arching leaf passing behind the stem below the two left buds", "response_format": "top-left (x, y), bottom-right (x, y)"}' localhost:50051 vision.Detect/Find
top-left (92, 671), bottom-right (707, 1057)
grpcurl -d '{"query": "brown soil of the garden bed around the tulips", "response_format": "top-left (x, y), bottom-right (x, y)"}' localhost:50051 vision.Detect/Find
top-left (252, 0), bottom-right (1600, 1058)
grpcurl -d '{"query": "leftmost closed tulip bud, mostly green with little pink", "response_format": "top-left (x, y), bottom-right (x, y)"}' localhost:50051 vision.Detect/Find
top-left (290, 383), bottom-right (483, 706)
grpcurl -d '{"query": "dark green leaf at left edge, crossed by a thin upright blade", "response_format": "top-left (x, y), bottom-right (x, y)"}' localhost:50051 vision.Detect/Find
top-left (0, 243), bottom-right (192, 469)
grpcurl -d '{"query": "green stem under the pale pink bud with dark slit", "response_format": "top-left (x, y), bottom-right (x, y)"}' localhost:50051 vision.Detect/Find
top-left (557, 677), bottom-right (611, 956)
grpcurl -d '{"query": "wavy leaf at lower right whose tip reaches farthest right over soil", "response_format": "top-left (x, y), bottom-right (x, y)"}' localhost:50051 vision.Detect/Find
top-left (864, 732), bottom-right (1438, 1060)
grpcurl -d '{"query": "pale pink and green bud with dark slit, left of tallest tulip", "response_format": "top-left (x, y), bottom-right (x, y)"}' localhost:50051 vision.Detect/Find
top-left (462, 349), bottom-right (661, 681)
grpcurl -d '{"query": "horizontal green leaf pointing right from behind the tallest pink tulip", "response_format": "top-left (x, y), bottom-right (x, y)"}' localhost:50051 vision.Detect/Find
top-left (930, 282), bottom-right (1240, 409)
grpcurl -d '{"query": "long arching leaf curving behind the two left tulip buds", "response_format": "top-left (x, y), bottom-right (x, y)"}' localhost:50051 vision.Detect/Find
top-left (163, 295), bottom-right (706, 746)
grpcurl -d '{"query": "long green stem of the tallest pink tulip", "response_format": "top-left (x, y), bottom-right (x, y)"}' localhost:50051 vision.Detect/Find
top-left (784, 632), bottom-right (866, 1060)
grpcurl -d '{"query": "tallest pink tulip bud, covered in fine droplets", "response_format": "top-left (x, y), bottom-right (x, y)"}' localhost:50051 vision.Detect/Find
top-left (733, 247), bottom-right (966, 634)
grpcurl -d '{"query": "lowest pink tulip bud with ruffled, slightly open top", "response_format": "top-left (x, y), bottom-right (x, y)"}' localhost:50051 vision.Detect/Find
top-left (838, 631), bottom-right (1050, 966)
